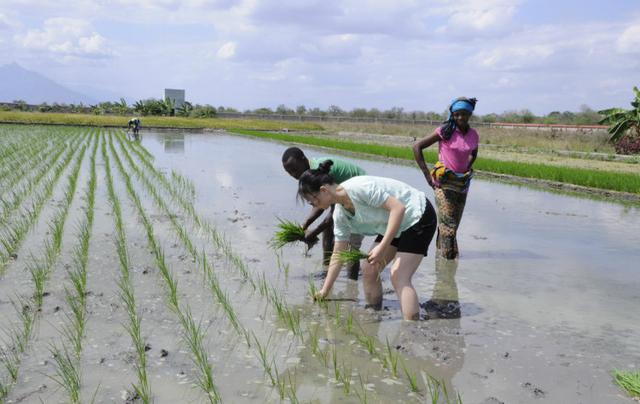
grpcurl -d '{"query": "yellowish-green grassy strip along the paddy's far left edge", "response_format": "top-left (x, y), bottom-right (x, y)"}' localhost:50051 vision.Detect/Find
top-left (0, 111), bottom-right (322, 130)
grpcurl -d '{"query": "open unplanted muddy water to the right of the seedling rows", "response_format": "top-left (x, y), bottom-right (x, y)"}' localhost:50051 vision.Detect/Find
top-left (136, 132), bottom-right (640, 403)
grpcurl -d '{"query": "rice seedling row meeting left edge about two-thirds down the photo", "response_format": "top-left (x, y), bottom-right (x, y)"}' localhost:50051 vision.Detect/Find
top-left (0, 131), bottom-right (86, 276)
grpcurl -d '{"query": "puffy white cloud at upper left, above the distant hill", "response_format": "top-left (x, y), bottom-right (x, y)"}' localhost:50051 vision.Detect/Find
top-left (17, 17), bottom-right (112, 58)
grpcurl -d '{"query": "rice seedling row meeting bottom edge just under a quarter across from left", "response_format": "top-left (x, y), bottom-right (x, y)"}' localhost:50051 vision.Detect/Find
top-left (101, 136), bottom-right (151, 403)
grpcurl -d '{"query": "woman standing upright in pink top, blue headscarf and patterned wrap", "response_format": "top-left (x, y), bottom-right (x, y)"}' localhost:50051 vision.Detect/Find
top-left (413, 97), bottom-right (479, 259)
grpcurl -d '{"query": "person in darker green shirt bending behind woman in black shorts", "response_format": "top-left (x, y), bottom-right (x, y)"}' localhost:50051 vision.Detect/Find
top-left (282, 147), bottom-right (366, 280)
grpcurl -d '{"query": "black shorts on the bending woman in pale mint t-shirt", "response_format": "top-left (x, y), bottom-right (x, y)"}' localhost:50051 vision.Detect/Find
top-left (376, 199), bottom-right (438, 257)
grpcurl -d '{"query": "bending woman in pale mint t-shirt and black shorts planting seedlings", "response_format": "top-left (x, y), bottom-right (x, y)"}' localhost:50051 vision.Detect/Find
top-left (298, 160), bottom-right (437, 320)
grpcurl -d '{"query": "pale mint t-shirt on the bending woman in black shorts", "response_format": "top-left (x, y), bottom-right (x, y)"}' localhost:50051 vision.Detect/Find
top-left (333, 175), bottom-right (427, 241)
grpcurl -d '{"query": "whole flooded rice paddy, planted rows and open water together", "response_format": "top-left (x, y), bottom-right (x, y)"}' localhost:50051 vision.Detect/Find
top-left (0, 126), bottom-right (640, 403)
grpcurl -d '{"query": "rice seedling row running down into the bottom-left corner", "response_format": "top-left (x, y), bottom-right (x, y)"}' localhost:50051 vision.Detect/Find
top-left (0, 137), bottom-right (86, 399)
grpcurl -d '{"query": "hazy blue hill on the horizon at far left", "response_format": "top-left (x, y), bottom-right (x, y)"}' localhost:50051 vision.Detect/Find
top-left (0, 63), bottom-right (97, 105)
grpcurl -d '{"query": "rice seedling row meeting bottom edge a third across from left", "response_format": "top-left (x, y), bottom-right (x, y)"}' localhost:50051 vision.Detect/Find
top-left (108, 134), bottom-right (221, 403)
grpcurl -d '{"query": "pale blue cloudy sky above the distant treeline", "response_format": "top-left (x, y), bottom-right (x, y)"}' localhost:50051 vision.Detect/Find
top-left (0, 0), bottom-right (640, 115)
